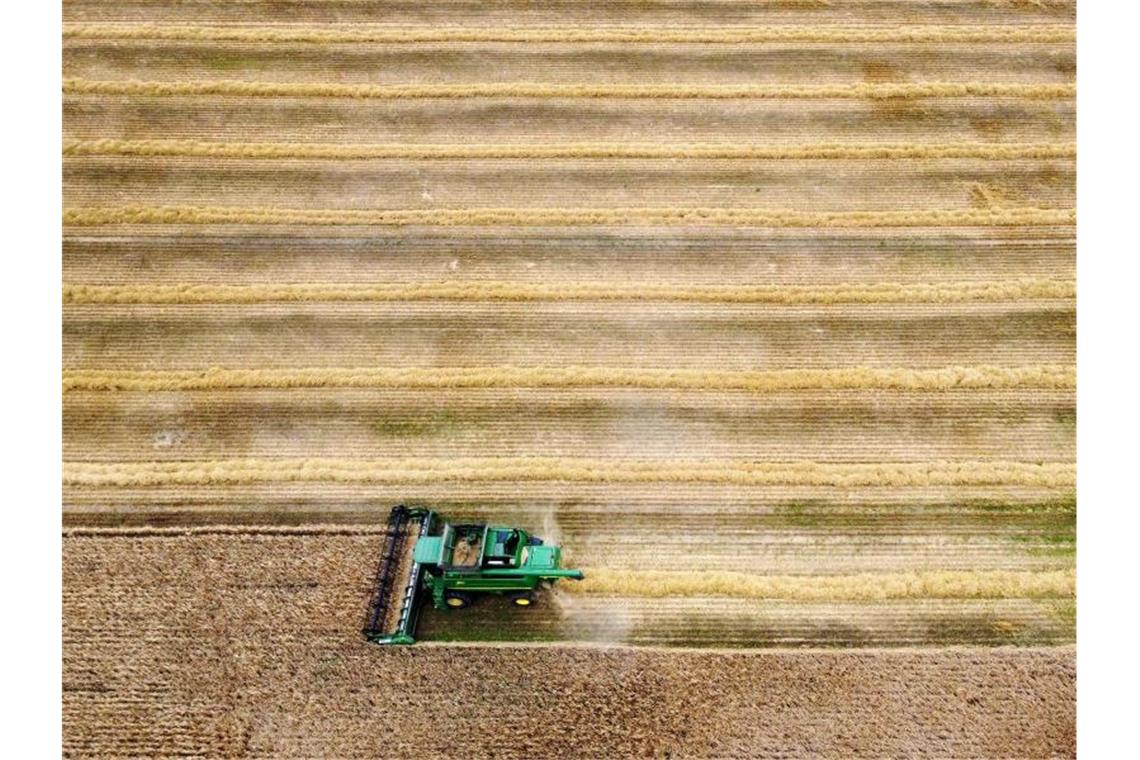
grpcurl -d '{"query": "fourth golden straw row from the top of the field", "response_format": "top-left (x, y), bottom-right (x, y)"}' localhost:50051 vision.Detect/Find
top-left (63, 205), bottom-right (1076, 228)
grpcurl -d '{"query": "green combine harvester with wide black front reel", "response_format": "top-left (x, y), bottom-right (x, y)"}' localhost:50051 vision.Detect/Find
top-left (364, 505), bottom-right (583, 644)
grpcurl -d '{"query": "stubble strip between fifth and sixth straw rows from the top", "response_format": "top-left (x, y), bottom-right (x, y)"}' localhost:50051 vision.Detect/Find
top-left (64, 302), bottom-right (1075, 371)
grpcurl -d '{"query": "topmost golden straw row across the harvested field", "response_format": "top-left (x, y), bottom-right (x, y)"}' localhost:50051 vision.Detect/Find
top-left (64, 24), bottom-right (1076, 44)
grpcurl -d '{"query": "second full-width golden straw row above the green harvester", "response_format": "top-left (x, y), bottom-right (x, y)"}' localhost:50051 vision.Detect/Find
top-left (63, 365), bottom-right (1076, 392)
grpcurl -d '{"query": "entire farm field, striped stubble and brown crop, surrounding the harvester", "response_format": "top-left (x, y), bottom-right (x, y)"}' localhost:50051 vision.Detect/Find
top-left (62, 0), bottom-right (1076, 757)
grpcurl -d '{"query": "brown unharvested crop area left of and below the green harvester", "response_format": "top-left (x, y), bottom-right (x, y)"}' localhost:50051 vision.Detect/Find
top-left (64, 536), bottom-right (1075, 758)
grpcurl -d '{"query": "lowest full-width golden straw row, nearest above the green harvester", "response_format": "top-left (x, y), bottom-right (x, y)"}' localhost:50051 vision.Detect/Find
top-left (64, 457), bottom-right (1076, 488)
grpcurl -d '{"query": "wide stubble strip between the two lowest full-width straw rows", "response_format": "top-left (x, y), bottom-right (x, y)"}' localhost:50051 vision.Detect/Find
top-left (64, 389), bottom-right (1076, 461)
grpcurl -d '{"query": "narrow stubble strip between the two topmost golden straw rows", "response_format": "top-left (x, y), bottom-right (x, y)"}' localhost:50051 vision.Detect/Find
top-left (63, 40), bottom-right (1076, 87)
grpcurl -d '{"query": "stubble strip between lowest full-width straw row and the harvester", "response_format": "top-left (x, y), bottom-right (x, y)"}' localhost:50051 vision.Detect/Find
top-left (64, 482), bottom-right (1074, 528)
